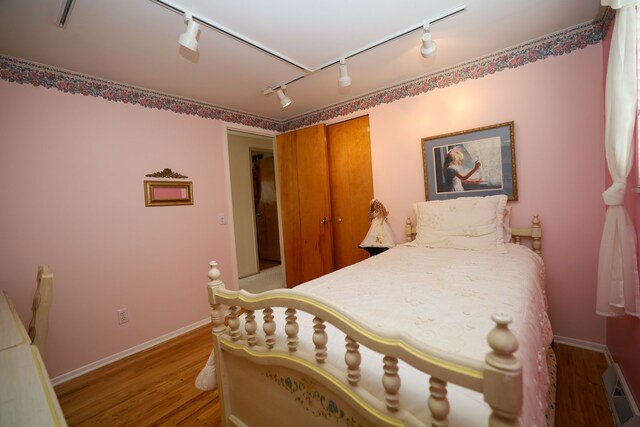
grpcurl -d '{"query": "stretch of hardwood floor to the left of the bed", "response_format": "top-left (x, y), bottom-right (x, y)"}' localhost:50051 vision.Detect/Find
top-left (55, 325), bottom-right (222, 426)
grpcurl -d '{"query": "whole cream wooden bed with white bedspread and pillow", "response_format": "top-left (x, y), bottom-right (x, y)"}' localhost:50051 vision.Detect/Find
top-left (196, 196), bottom-right (552, 426)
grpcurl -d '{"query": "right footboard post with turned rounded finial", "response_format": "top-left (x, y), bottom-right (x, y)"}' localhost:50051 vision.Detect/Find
top-left (483, 313), bottom-right (522, 427)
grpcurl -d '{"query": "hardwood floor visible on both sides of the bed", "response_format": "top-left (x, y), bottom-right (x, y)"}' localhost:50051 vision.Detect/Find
top-left (55, 325), bottom-right (614, 427)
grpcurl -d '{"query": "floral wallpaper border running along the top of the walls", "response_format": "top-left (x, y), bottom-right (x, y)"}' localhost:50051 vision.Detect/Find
top-left (0, 13), bottom-right (615, 132)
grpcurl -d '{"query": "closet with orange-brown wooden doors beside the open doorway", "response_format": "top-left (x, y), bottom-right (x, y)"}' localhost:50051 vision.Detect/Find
top-left (276, 116), bottom-right (373, 288)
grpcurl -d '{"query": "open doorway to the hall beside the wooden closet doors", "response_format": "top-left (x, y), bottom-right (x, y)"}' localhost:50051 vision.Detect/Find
top-left (227, 129), bottom-right (284, 293)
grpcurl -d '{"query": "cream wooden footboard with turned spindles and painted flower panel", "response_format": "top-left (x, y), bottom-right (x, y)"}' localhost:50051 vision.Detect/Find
top-left (200, 261), bottom-right (523, 426)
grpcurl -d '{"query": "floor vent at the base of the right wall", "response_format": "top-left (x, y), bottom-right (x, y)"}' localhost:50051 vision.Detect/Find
top-left (602, 363), bottom-right (640, 427)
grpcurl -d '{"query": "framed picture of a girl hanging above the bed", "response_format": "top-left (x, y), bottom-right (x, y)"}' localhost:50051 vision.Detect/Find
top-left (422, 122), bottom-right (518, 200)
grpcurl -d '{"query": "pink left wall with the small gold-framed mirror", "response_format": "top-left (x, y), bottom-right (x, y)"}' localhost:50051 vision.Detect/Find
top-left (0, 80), bottom-right (232, 377)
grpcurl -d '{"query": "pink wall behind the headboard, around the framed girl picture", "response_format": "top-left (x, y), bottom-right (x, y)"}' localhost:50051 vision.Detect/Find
top-left (358, 45), bottom-right (605, 343)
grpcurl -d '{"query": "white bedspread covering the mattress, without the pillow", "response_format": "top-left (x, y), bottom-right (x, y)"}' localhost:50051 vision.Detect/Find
top-left (296, 244), bottom-right (552, 426)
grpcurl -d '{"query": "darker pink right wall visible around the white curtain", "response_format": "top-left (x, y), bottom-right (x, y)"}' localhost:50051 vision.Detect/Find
top-left (602, 12), bottom-right (640, 402)
